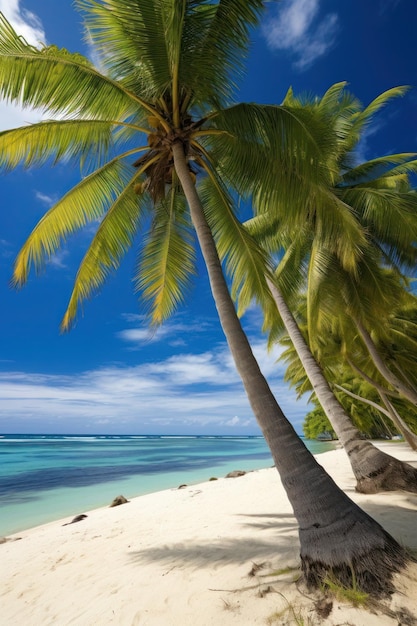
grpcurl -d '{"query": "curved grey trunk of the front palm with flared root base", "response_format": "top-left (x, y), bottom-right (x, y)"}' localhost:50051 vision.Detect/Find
top-left (173, 143), bottom-right (407, 594)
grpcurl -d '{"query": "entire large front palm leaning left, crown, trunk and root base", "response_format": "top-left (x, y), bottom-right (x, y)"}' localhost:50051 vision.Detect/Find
top-left (0, 0), bottom-right (407, 593)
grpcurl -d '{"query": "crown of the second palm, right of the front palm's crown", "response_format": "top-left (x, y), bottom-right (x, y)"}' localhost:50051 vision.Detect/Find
top-left (247, 83), bottom-right (417, 326)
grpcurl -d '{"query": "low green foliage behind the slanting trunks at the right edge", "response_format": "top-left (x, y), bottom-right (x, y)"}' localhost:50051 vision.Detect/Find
top-left (279, 296), bottom-right (417, 438)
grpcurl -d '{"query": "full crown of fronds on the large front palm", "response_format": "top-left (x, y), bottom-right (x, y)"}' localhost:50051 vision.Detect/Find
top-left (0, 0), bottom-right (325, 329)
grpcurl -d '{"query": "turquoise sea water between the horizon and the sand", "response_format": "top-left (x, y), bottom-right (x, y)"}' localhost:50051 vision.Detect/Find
top-left (0, 435), bottom-right (334, 537)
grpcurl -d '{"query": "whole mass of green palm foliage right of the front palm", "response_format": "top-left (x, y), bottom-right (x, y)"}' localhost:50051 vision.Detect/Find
top-left (246, 83), bottom-right (417, 436)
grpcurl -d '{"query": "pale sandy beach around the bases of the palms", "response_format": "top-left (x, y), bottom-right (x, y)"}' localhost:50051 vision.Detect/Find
top-left (0, 443), bottom-right (417, 626)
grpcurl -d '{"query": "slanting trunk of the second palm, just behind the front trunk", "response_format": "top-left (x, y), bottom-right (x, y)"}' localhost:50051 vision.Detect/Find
top-left (268, 280), bottom-right (417, 493)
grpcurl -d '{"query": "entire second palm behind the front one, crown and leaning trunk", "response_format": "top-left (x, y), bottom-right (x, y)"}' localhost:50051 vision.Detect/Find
top-left (247, 83), bottom-right (417, 493)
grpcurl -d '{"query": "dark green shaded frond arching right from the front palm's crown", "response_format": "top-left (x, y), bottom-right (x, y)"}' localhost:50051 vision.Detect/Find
top-left (206, 104), bottom-right (334, 211)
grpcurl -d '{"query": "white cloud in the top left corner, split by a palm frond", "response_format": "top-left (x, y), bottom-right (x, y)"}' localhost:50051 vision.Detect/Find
top-left (0, 0), bottom-right (46, 130)
